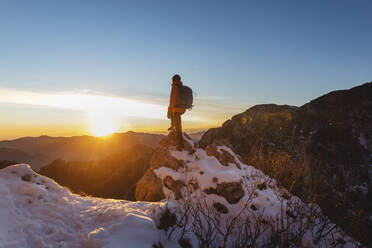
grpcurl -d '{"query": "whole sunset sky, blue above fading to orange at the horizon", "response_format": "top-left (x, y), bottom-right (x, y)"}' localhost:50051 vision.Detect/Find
top-left (0, 0), bottom-right (372, 140)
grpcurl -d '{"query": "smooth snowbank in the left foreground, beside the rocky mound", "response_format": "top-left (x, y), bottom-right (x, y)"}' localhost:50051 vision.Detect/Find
top-left (0, 164), bottom-right (173, 248)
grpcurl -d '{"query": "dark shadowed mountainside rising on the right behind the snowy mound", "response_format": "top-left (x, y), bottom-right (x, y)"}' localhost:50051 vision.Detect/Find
top-left (198, 82), bottom-right (372, 244)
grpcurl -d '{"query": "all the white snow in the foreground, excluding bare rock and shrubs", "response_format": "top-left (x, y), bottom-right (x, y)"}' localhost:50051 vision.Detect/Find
top-left (0, 140), bottom-right (360, 248)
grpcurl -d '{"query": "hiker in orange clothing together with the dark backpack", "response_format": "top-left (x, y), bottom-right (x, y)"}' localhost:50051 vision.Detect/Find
top-left (167, 74), bottom-right (193, 150)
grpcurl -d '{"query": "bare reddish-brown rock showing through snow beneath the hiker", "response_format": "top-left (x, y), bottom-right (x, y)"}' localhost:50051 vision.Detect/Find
top-left (136, 133), bottom-right (245, 207)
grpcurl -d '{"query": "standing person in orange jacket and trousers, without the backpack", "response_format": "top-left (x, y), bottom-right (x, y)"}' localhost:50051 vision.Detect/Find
top-left (167, 74), bottom-right (186, 150)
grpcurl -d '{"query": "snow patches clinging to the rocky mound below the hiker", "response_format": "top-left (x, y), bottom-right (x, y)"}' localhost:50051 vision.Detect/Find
top-left (154, 146), bottom-right (356, 247)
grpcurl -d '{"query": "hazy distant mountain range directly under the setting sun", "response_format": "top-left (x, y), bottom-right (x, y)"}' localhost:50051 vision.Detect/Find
top-left (0, 132), bottom-right (164, 171)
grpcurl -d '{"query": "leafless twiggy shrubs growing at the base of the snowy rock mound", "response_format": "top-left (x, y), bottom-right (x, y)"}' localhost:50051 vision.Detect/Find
top-left (155, 169), bottom-right (356, 248)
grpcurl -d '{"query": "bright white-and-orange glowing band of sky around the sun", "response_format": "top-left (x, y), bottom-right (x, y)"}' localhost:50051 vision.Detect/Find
top-left (0, 88), bottom-right (235, 140)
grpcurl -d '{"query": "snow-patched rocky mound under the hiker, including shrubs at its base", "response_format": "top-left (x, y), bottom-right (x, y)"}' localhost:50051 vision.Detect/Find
top-left (136, 133), bottom-right (357, 247)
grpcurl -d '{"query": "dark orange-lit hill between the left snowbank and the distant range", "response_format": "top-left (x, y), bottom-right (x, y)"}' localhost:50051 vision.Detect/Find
top-left (40, 144), bottom-right (154, 200)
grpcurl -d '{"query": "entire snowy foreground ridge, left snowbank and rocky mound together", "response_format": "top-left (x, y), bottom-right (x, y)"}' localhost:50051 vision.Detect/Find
top-left (0, 136), bottom-right (358, 248)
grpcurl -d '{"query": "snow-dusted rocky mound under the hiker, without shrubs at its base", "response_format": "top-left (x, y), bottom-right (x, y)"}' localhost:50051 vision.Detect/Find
top-left (136, 136), bottom-right (357, 247)
